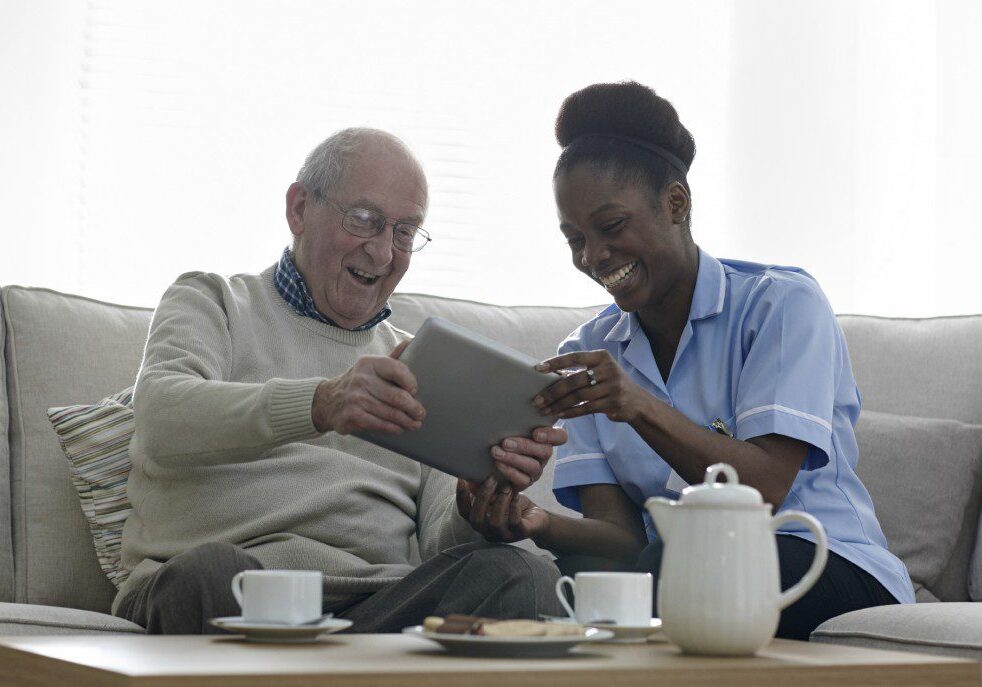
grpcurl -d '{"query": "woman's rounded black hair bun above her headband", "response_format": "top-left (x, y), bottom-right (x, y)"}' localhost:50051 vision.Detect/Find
top-left (556, 81), bottom-right (696, 166)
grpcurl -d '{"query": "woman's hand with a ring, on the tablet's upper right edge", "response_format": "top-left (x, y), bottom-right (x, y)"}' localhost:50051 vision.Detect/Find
top-left (532, 350), bottom-right (651, 424)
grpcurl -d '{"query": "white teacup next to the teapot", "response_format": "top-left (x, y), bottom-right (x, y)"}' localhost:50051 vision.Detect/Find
top-left (556, 572), bottom-right (652, 627)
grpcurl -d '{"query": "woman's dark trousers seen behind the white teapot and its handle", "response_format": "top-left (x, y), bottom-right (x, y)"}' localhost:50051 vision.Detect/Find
top-left (637, 535), bottom-right (897, 641)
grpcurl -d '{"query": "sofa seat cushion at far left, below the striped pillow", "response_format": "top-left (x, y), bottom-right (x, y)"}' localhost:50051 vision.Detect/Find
top-left (0, 603), bottom-right (144, 635)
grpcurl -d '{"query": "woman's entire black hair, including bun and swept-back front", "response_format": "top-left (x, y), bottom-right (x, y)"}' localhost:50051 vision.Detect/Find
top-left (553, 81), bottom-right (696, 198)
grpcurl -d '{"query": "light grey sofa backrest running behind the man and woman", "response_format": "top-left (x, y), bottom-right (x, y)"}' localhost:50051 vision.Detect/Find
top-left (0, 286), bottom-right (982, 611)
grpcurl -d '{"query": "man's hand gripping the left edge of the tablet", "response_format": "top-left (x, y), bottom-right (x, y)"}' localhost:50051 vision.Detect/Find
top-left (310, 341), bottom-right (426, 434)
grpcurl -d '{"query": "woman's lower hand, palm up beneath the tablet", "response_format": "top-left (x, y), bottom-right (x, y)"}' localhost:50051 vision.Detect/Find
top-left (457, 477), bottom-right (549, 542)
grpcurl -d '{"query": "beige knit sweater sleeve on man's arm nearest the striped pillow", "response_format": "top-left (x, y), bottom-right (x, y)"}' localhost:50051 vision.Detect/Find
top-left (133, 273), bottom-right (323, 467)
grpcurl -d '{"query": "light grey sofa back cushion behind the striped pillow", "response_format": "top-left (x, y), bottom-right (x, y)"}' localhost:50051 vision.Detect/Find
top-left (3, 286), bottom-right (150, 611)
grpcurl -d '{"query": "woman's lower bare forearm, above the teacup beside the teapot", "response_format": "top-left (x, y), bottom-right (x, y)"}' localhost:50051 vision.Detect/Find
top-left (532, 511), bottom-right (647, 564)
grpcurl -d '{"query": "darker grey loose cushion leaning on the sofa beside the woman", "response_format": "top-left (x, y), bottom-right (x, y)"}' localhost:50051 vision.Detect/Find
top-left (856, 411), bottom-right (982, 601)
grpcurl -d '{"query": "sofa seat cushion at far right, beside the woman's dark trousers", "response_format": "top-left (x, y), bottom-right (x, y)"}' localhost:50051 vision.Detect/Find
top-left (811, 602), bottom-right (982, 661)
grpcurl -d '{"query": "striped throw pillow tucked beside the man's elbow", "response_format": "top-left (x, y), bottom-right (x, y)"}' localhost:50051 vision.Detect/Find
top-left (48, 387), bottom-right (133, 587)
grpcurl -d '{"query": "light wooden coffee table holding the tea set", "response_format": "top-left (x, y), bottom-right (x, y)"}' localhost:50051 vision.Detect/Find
top-left (0, 634), bottom-right (980, 687)
